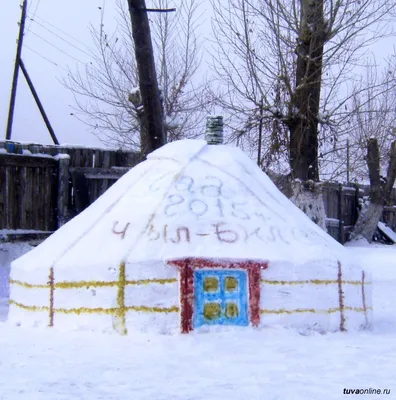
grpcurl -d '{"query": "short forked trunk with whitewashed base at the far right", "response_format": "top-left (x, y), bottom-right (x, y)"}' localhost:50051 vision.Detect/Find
top-left (351, 139), bottom-right (396, 243)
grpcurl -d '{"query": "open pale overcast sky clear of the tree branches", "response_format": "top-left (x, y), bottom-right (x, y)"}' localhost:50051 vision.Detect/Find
top-left (0, 0), bottom-right (393, 146)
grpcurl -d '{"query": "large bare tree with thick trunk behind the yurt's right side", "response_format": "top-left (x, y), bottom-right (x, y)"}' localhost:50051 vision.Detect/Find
top-left (212, 0), bottom-right (396, 181)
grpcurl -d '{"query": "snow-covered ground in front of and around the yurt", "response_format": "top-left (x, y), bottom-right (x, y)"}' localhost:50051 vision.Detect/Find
top-left (0, 244), bottom-right (396, 400)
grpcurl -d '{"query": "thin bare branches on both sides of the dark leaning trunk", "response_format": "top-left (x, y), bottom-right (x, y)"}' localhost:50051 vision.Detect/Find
top-left (65, 0), bottom-right (204, 151)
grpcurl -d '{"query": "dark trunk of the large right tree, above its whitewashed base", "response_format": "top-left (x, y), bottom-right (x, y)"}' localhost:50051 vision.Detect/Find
top-left (289, 0), bottom-right (327, 181)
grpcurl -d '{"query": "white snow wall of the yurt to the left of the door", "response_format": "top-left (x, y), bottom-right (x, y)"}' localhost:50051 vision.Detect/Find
top-left (8, 262), bottom-right (180, 334)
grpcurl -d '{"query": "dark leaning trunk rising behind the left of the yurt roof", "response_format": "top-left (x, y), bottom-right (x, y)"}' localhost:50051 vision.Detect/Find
top-left (128, 0), bottom-right (166, 155)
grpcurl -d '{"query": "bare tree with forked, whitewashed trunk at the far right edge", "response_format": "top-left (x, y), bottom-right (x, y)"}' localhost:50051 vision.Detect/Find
top-left (328, 56), bottom-right (396, 242)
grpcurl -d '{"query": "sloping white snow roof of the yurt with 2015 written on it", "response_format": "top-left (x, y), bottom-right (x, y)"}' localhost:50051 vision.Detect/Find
top-left (13, 140), bottom-right (352, 269)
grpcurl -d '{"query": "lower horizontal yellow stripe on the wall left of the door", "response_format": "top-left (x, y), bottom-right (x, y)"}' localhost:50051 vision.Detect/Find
top-left (9, 300), bottom-right (179, 314)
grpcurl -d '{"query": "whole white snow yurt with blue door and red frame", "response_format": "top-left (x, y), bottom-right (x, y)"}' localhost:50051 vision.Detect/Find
top-left (9, 140), bottom-right (372, 334)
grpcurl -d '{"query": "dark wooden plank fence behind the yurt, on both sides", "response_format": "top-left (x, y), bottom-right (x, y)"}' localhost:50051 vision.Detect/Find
top-left (0, 141), bottom-right (396, 243)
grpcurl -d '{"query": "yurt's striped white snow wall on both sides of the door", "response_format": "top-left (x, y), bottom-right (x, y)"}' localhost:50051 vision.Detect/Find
top-left (9, 260), bottom-right (372, 334)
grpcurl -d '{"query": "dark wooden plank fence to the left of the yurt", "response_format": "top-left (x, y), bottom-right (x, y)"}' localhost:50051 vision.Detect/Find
top-left (0, 141), bottom-right (141, 235)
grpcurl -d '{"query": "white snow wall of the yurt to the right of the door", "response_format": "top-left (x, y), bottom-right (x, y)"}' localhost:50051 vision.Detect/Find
top-left (260, 260), bottom-right (372, 332)
